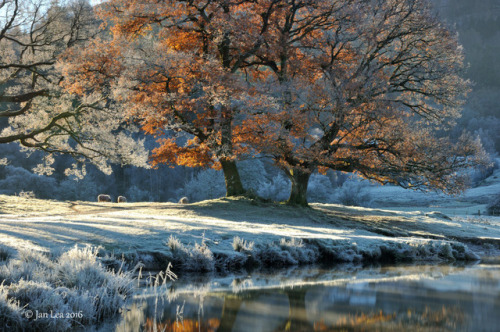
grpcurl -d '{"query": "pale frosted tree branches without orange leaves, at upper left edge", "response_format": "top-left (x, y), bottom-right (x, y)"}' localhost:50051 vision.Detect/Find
top-left (0, 0), bottom-right (147, 173)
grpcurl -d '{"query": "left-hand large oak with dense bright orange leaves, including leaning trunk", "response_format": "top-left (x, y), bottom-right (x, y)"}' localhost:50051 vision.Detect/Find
top-left (63, 0), bottom-right (290, 196)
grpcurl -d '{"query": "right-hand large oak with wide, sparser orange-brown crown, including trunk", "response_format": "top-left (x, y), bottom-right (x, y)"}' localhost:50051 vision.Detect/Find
top-left (238, 0), bottom-right (485, 205)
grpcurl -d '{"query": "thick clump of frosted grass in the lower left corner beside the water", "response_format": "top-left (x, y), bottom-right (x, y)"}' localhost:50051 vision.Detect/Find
top-left (0, 246), bottom-right (134, 331)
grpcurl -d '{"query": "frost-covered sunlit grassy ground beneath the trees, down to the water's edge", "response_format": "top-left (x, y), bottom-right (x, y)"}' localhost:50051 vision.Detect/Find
top-left (0, 167), bottom-right (500, 271)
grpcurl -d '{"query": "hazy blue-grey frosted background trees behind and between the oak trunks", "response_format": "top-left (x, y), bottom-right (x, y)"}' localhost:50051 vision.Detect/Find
top-left (0, 139), bottom-right (371, 206)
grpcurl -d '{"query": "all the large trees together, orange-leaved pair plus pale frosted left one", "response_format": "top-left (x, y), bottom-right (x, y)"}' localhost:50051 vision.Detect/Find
top-left (0, 0), bottom-right (487, 205)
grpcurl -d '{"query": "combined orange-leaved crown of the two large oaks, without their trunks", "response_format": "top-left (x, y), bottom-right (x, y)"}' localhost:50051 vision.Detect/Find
top-left (57, 0), bottom-right (480, 192)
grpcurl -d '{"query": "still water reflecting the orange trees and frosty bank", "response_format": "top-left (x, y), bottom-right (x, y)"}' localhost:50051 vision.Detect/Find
top-left (113, 264), bottom-right (500, 332)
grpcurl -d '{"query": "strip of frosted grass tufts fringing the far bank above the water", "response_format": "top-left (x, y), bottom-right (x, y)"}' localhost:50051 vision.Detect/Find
top-left (161, 233), bottom-right (479, 272)
